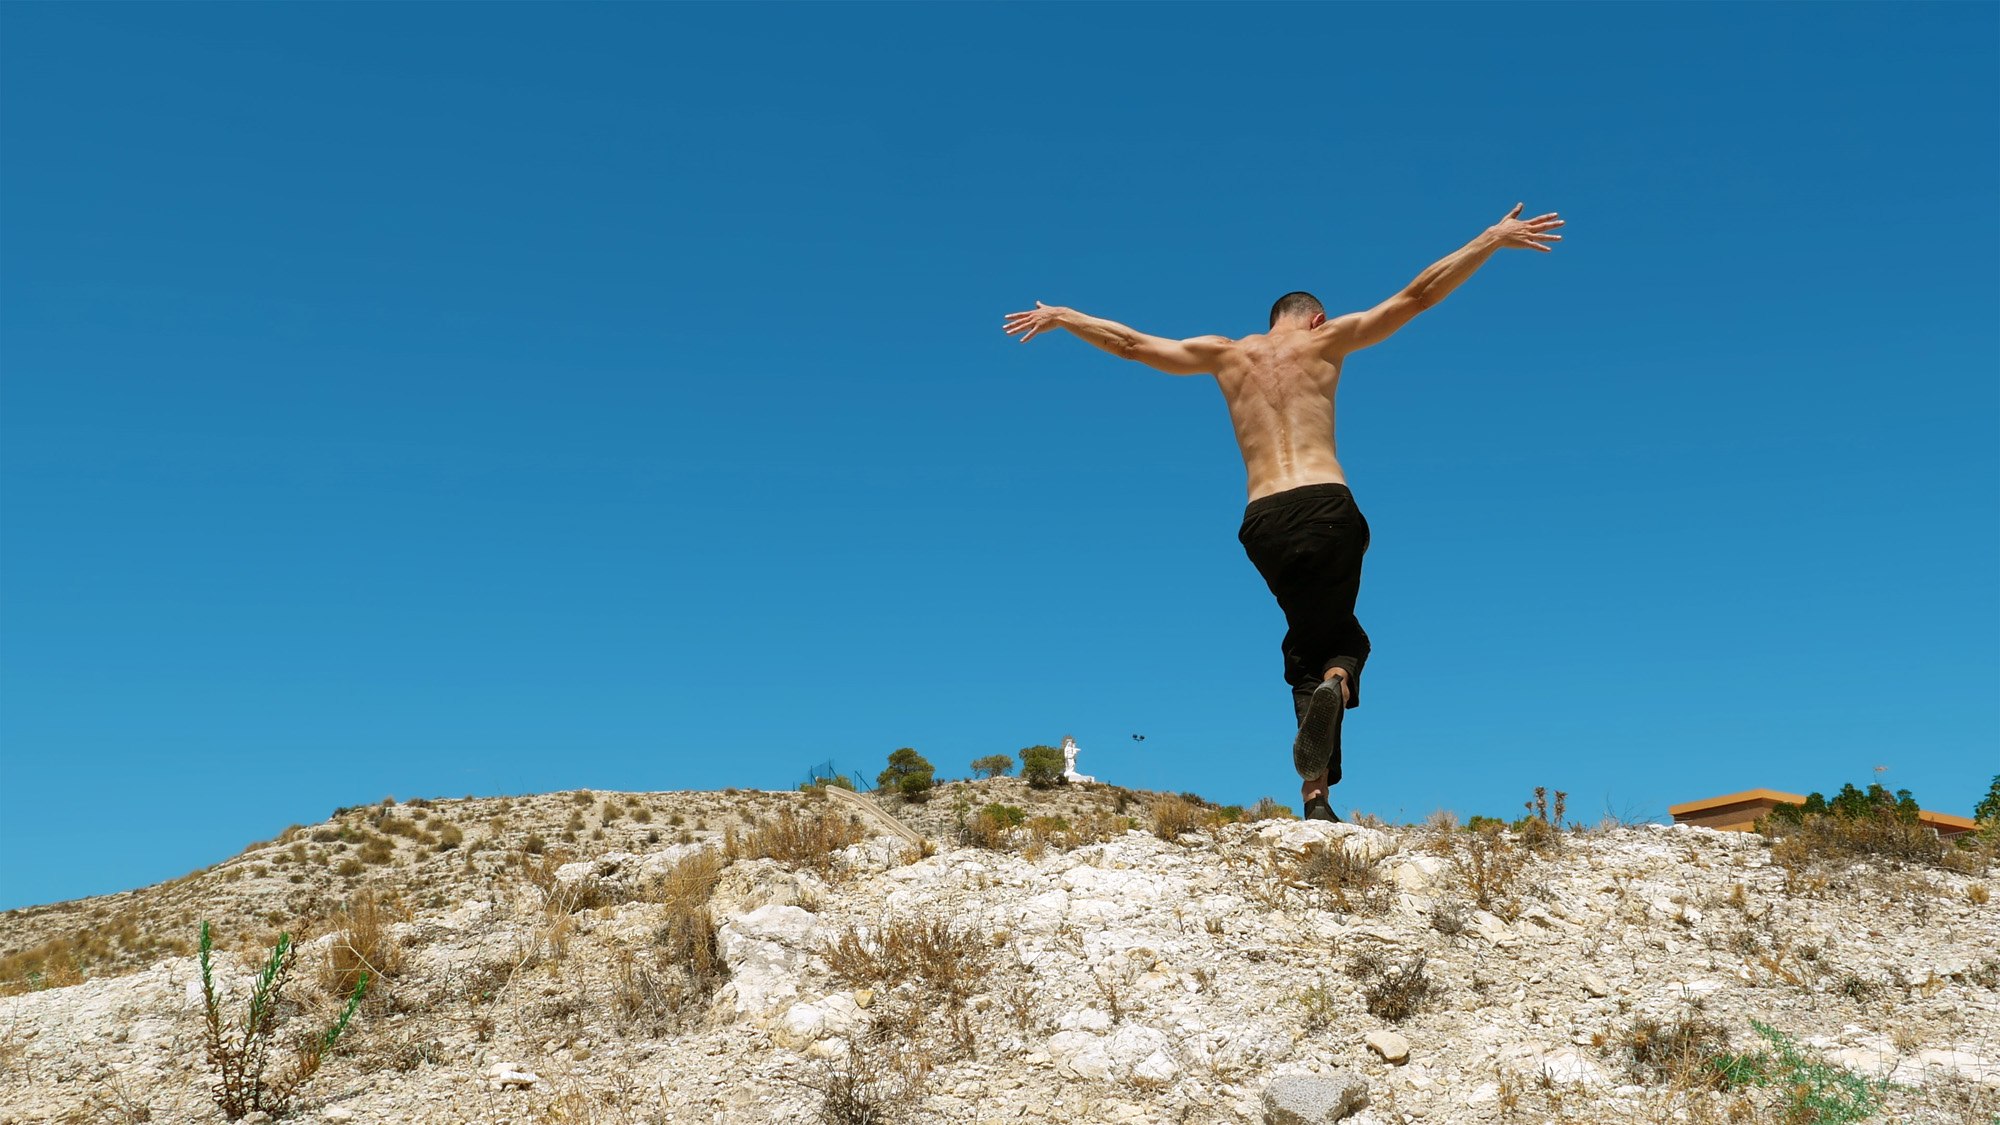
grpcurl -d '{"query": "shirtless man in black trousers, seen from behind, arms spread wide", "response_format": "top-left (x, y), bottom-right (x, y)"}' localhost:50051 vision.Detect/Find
top-left (1006, 204), bottom-right (1562, 821)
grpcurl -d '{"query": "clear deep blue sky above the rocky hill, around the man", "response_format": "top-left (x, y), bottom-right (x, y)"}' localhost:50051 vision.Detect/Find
top-left (0, 4), bottom-right (2000, 907)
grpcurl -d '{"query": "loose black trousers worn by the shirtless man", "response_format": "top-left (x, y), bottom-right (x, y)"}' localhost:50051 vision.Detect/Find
top-left (1236, 484), bottom-right (1368, 736)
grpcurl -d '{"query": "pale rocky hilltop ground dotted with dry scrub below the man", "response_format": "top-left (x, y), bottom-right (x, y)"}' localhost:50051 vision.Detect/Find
top-left (0, 779), bottom-right (2000, 1125)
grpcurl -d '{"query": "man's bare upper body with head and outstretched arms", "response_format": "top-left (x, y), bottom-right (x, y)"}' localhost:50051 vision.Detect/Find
top-left (1006, 204), bottom-right (1562, 500)
